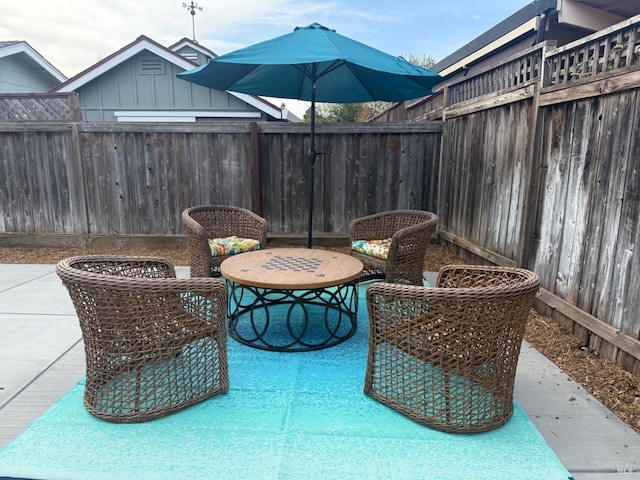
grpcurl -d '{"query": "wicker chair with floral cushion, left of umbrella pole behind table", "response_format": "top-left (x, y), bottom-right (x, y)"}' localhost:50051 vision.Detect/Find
top-left (182, 205), bottom-right (267, 277)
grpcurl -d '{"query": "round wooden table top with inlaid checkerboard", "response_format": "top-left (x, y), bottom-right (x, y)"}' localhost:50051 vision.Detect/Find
top-left (220, 248), bottom-right (363, 290)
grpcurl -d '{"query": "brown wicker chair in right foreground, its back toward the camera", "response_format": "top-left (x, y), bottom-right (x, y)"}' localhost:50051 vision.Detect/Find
top-left (364, 265), bottom-right (540, 433)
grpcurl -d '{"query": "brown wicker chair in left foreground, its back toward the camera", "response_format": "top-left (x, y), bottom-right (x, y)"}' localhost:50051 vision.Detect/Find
top-left (56, 255), bottom-right (229, 423)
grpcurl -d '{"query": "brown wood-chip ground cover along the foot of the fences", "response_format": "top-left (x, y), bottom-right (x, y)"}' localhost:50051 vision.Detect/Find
top-left (0, 245), bottom-right (640, 433)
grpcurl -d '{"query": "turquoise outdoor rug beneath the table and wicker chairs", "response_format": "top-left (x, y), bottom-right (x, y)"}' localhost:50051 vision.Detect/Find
top-left (0, 284), bottom-right (570, 480)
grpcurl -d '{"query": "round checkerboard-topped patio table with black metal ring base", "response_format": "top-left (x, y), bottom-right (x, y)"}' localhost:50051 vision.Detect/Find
top-left (220, 248), bottom-right (363, 352)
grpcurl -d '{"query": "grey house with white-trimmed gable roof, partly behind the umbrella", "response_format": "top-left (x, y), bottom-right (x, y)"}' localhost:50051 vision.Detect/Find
top-left (51, 35), bottom-right (301, 122)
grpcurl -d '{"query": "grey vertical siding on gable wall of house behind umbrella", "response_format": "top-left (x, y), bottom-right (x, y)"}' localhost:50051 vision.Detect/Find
top-left (77, 51), bottom-right (266, 122)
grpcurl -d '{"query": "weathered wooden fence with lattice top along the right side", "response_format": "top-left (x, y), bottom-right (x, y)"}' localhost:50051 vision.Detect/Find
top-left (436, 16), bottom-right (640, 374)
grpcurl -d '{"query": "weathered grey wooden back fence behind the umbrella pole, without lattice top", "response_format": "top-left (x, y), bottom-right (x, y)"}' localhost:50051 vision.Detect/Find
top-left (0, 122), bottom-right (442, 248)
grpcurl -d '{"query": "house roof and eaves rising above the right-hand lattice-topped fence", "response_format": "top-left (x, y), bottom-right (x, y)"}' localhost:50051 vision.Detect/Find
top-left (430, 0), bottom-right (640, 83)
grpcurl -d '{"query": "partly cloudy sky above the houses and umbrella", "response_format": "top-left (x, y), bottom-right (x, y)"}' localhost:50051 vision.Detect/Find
top-left (0, 0), bottom-right (532, 116)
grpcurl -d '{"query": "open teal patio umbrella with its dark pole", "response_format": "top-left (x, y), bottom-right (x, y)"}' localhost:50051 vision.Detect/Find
top-left (178, 23), bottom-right (441, 248)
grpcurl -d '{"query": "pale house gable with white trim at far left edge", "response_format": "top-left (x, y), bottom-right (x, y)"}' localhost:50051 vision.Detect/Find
top-left (0, 41), bottom-right (67, 94)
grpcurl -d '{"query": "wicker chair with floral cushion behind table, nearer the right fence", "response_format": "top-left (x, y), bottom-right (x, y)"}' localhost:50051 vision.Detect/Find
top-left (349, 210), bottom-right (438, 285)
